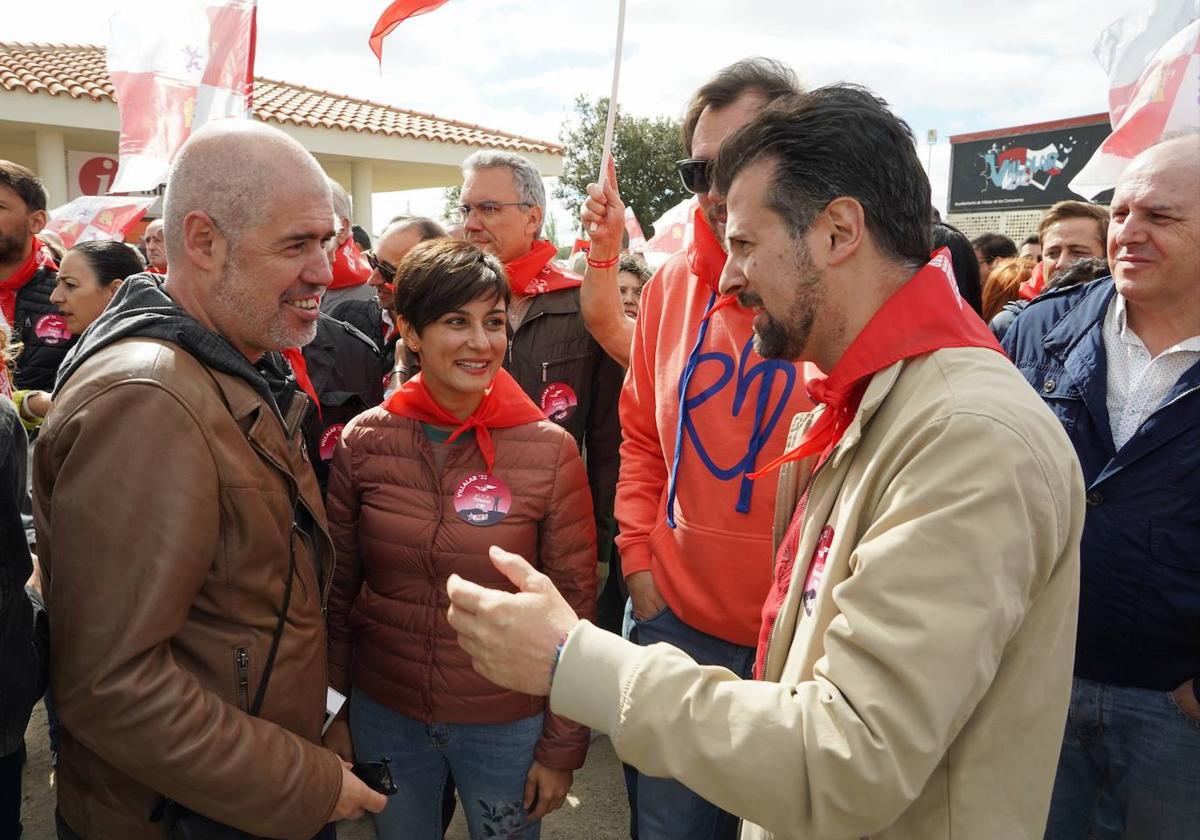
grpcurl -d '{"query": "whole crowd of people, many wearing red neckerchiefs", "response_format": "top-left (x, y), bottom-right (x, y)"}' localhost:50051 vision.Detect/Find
top-left (0, 52), bottom-right (1200, 840)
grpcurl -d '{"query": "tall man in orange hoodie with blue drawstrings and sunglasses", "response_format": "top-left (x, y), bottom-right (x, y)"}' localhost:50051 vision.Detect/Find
top-left (583, 59), bottom-right (811, 840)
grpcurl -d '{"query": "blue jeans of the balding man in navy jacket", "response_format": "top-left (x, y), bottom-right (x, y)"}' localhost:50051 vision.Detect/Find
top-left (1045, 678), bottom-right (1200, 840)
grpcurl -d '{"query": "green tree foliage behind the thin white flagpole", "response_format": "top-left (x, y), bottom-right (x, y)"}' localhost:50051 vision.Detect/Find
top-left (554, 96), bottom-right (688, 238)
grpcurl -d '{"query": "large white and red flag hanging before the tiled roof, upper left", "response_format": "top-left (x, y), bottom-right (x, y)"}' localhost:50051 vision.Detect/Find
top-left (107, 0), bottom-right (256, 192)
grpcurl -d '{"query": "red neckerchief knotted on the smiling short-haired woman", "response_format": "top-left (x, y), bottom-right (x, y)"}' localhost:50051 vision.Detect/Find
top-left (383, 367), bottom-right (546, 473)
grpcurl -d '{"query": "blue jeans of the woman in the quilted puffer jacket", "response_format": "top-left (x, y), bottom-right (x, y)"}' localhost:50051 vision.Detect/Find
top-left (350, 691), bottom-right (542, 840)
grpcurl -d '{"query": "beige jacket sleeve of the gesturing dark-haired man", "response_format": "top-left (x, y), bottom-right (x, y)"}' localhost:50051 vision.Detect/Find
top-left (551, 414), bottom-right (1082, 838)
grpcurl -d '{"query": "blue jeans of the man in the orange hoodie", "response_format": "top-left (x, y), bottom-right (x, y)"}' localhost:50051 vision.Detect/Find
top-left (632, 607), bottom-right (755, 840)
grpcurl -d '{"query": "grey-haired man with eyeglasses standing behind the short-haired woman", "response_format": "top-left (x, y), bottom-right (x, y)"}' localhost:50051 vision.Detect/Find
top-left (455, 151), bottom-right (624, 638)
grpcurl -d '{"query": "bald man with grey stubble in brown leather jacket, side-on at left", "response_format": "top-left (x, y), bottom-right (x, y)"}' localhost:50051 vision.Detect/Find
top-left (34, 120), bottom-right (385, 840)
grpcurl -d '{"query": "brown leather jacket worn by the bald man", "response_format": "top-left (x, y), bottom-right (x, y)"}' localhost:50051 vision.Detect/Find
top-left (34, 338), bottom-right (342, 840)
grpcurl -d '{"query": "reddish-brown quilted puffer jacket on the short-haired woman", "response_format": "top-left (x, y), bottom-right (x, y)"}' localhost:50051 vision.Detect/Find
top-left (326, 408), bottom-right (596, 770)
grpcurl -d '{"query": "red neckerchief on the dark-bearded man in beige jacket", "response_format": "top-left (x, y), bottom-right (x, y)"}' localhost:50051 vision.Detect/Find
top-left (749, 248), bottom-right (1003, 479)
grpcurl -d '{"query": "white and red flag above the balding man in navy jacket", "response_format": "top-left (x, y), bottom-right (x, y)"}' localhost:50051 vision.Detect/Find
top-left (1070, 0), bottom-right (1200, 198)
